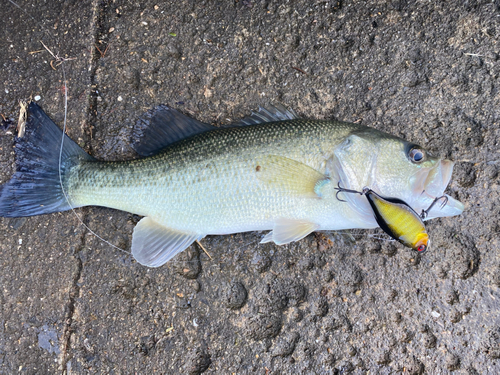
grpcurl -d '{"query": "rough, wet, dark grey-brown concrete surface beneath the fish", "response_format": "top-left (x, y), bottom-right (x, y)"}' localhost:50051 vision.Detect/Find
top-left (0, 0), bottom-right (500, 375)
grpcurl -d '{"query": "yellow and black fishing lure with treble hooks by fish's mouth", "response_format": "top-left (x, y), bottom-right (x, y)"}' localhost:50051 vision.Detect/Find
top-left (336, 184), bottom-right (447, 253)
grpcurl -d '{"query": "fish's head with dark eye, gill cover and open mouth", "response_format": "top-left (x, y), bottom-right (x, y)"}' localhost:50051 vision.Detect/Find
top-left (332, 129), bottom-right (464, 220)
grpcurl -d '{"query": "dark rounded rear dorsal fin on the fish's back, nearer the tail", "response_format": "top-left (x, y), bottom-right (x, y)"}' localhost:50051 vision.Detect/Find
top-left (131, 105), bottom-right (216, 156)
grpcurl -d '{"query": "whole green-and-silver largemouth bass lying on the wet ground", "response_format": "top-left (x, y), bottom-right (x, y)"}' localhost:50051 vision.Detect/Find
top-left (0, 102), bottom-right (464, 267)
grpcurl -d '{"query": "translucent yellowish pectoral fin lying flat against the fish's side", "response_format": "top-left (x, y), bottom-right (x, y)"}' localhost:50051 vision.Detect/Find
top-left (255, 155), bottom-right (330, 198)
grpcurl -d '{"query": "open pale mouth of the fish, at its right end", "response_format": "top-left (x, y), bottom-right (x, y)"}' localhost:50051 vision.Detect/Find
top-left (413, 160), bottom-right (464, 220)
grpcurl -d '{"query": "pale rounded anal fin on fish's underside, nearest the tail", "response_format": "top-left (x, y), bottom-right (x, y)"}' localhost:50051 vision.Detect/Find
top-left (132, 217), bottom-right (204, 267)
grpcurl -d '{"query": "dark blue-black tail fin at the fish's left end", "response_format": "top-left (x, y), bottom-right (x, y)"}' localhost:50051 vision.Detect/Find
top-left (0, 102), bottom-right (93, 217)
